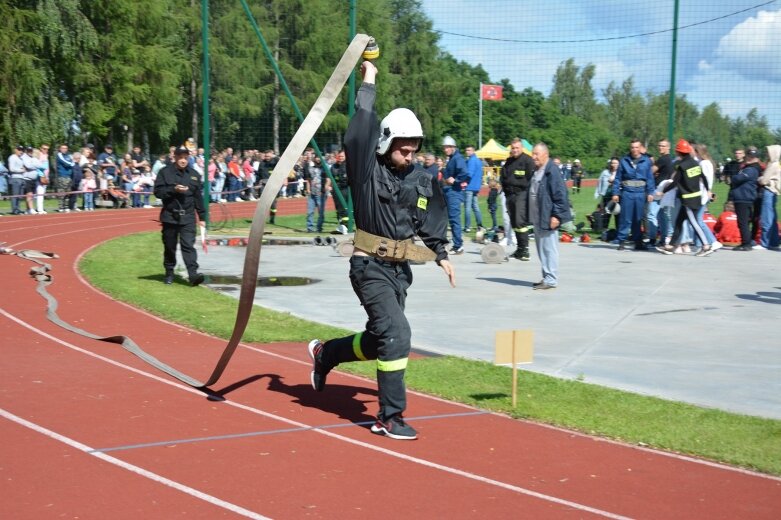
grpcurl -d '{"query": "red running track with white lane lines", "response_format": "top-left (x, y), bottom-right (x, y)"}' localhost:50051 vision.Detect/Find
top-left (0, 200), bottom-right (781, 519)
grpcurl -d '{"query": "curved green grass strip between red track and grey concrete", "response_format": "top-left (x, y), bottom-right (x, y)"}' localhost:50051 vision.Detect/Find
top-left (79, 216), bottom-right (781, 475)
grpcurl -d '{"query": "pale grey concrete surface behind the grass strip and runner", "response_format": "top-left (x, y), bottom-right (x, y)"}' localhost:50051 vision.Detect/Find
top-left (199, 237), bottom-right (781, 419)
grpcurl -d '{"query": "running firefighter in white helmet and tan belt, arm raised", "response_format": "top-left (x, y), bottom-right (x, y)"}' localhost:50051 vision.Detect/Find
top-left (308, 61), bottom-right (455, 440)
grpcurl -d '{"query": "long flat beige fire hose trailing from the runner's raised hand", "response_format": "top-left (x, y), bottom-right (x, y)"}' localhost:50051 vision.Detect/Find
top-left (10, 34), bottom-right (371, 389)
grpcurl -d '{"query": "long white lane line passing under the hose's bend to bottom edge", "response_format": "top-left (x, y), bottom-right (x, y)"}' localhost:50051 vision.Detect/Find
top-left (0, 308), bottom-right (629, 520)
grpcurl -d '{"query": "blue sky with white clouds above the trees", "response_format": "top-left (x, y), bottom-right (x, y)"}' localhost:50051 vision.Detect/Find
top-left (422, 0), bottom-right (781, 128)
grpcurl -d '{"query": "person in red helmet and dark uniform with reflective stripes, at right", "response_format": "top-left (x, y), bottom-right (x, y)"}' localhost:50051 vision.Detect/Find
top-left (656, 139), bottom-right (713, 256)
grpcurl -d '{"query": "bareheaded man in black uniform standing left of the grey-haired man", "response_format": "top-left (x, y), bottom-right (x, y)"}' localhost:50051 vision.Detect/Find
top-left (499, 137), bottom-right (537, 262)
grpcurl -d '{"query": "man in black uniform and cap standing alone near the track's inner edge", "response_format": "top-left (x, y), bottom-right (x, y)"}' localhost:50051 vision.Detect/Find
top-left (155, 146), bottom-right (206, 285)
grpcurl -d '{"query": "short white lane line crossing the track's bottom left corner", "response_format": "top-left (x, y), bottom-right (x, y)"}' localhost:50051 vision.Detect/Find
top-left (0, 408), bottom-right (269, 520)
